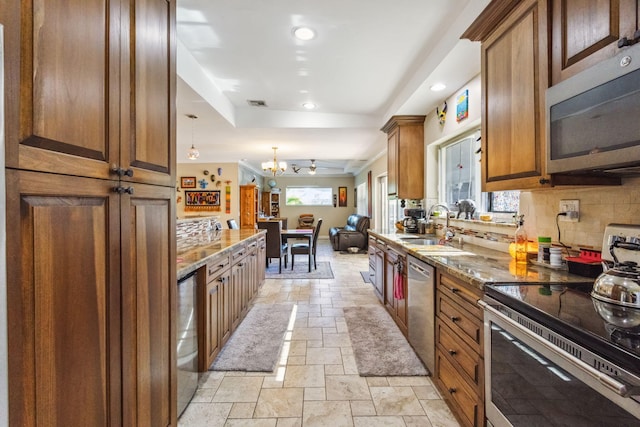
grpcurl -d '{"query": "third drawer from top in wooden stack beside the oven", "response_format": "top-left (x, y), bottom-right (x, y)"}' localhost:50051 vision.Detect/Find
top-left (436, 319), bottom-right (484, 396)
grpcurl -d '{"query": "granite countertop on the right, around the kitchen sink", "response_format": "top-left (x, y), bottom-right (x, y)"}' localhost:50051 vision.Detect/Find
top-left (369, 230), bottom-right (593, 290)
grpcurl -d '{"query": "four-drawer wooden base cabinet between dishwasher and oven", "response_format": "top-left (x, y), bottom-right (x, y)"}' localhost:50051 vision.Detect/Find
top-left (434, 271), bottom-right (484, 426)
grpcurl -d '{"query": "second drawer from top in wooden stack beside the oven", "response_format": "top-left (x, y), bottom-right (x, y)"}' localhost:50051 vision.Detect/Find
top-left (436, 292), bottom-right (482, 354)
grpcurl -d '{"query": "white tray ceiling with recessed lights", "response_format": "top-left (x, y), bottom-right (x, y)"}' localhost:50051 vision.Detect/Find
top-left (172, 0), bottom-right (489, 175)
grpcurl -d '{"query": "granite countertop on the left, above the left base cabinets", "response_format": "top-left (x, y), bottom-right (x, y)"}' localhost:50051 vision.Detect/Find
top-left (177, 229), bottom-right (266, 280)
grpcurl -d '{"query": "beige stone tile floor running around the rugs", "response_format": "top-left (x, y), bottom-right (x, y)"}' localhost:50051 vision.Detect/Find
top-left (178, 240), bottom-right (458, 427)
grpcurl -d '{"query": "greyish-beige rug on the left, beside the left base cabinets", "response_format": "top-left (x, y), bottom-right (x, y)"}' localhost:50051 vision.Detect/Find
top-left (209, 304), bottom-right (293, 372)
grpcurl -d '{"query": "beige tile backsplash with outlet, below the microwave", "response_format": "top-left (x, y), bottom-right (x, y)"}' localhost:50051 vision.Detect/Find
top-left (520, 178), bottom-right (640, 250)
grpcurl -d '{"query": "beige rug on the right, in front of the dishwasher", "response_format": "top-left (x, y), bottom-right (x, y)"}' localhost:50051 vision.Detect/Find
top-left (343, 305), bottom-right (429, 377)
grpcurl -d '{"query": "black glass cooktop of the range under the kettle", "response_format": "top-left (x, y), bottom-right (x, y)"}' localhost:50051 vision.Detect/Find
top-left (485, 283), bottom-right (640, 375)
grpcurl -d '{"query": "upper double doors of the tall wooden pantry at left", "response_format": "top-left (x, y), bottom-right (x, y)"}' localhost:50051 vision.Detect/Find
top-left (0, 0), bottom-right (175, 186)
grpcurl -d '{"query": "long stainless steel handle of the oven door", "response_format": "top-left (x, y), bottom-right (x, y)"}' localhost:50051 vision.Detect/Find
top-left (478, 300), bottom-right (638, 397)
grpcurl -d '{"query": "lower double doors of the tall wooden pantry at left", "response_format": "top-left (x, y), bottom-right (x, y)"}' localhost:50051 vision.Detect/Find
top-left (6, 170), bottom-right (177, 426)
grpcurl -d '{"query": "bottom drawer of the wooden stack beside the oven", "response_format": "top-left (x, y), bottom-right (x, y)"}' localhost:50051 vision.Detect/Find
top-left (436, 351), bottom-right (484, 426)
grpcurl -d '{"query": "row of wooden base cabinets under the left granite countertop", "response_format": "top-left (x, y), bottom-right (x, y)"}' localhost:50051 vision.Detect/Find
top-left (198, 235), bottom-right (266, 372)
